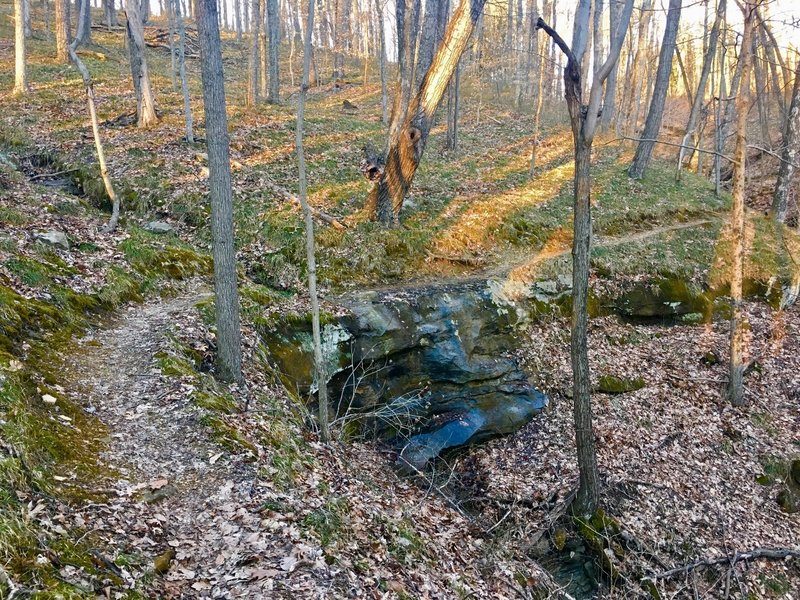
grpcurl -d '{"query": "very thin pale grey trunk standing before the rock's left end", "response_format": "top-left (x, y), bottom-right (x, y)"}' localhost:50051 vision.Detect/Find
top-left (296, 0), bottom-right (331, 443)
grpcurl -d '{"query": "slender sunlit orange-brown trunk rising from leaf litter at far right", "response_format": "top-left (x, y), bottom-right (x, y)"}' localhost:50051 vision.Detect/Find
top-left (728, 0), bottom-right (759, 406)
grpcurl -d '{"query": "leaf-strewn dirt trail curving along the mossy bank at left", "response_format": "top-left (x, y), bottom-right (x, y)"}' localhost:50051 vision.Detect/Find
top-left (64, 285), bottom-right (278, 597)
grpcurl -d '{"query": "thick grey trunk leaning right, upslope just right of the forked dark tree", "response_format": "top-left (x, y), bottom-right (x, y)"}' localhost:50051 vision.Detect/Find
top-left (628, 0), bottom-right (681, 179)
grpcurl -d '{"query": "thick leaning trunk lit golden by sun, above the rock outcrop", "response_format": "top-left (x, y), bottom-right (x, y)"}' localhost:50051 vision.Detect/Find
top-left (367, 0), bottom-right (486, 225)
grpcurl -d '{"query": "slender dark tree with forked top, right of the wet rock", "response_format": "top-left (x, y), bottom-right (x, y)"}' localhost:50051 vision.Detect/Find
top-left (536, 0), bottom-right (633, 514)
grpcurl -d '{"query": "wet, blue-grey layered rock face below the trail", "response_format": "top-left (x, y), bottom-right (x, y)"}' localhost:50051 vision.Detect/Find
top-left (260, 283), bottom-right (547, 468)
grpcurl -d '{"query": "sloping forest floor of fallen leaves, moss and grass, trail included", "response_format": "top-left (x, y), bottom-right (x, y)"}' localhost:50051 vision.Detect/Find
top-left (0, 4), bottom-right (800, 599)
